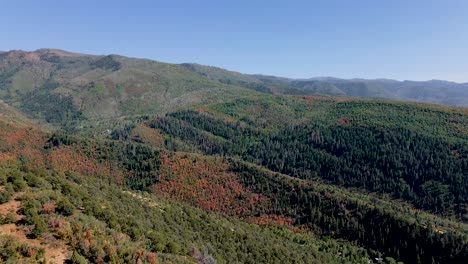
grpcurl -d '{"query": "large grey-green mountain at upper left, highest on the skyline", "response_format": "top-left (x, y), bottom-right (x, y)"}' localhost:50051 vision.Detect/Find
top-left (0, 49), bottom-right (260, 130)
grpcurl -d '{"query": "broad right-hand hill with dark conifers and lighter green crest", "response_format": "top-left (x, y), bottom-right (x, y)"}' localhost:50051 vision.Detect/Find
top-left (150, 98), bottom-right (468, 217)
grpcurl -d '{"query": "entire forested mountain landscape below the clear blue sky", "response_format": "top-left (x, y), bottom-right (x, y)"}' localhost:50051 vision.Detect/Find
top-left (0, 50), bottom-right (468, 264)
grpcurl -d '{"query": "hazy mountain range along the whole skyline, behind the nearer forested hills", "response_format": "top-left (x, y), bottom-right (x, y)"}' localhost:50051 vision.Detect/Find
top-left (0, 49), bottom-right (468, 129)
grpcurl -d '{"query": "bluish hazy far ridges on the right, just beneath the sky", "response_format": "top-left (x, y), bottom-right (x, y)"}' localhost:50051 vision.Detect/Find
top-left (183, 64), bottom-right (468, 106)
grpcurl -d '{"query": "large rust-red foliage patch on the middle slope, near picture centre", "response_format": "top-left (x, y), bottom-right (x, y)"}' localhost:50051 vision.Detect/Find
top-left (153, 154), bottom-right (267, 217)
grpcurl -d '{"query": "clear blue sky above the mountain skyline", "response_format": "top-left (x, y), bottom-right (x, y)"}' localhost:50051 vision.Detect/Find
top-left (0, 0), bottom-right (468, 82)
